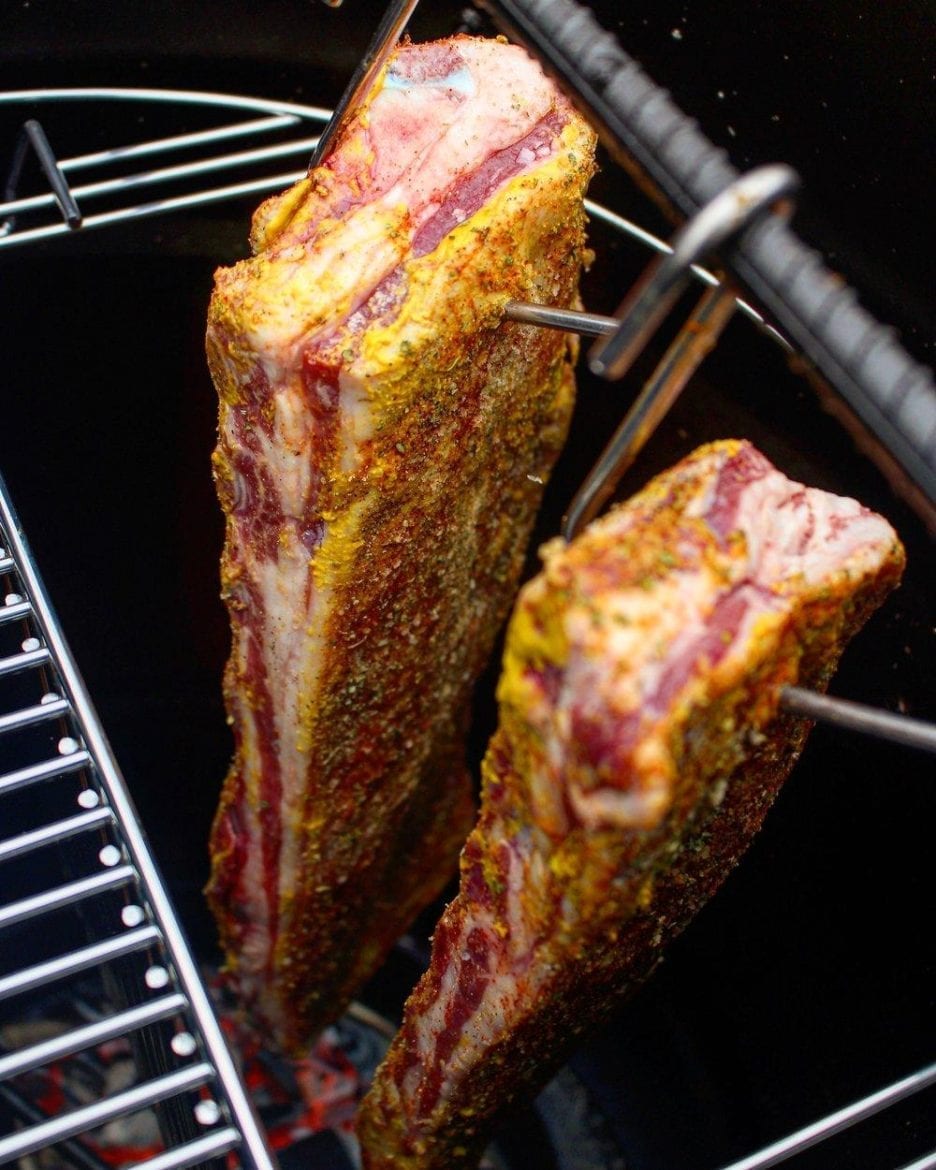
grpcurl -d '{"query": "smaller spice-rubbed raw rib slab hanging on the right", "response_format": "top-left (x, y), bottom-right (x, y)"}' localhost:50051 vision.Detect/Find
top-left (358, 441), bottom-right (903, 1170)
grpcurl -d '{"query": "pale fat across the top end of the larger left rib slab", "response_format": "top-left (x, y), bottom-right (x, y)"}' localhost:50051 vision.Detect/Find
top-left (241, 41), bottom-right (556, 374)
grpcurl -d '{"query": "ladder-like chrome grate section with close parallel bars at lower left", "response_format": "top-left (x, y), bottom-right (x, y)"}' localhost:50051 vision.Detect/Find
top-left (0, 470), bottom-right (275, 1170)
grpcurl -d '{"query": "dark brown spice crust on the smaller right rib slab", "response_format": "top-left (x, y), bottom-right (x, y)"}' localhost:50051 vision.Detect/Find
top-left (358, 439), bottom-right (903, 1170)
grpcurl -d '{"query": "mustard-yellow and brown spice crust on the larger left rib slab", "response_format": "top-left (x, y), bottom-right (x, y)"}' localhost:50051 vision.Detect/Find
top-left (207, 54), bottom-right (592, 1052)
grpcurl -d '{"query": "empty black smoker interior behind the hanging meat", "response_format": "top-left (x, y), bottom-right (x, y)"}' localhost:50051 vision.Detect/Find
top-left (0, 0), bottom-right (936, 1170)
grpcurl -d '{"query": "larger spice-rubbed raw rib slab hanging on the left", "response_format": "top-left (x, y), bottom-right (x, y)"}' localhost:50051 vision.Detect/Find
top-left (207, 37), bottom-right (593, 1051)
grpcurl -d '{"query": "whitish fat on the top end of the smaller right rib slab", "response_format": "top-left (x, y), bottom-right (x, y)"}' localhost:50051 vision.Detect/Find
top-left (552, 453), bottom-right (893, 827)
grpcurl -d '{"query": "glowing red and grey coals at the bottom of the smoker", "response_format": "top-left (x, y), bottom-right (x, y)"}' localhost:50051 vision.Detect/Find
top-left (0, 972), bottom-right (625, 1170)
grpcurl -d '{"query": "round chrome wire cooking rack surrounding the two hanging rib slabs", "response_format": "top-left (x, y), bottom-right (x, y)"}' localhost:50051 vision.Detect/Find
top-left (0, 88), bottom-right (936, 1170)
